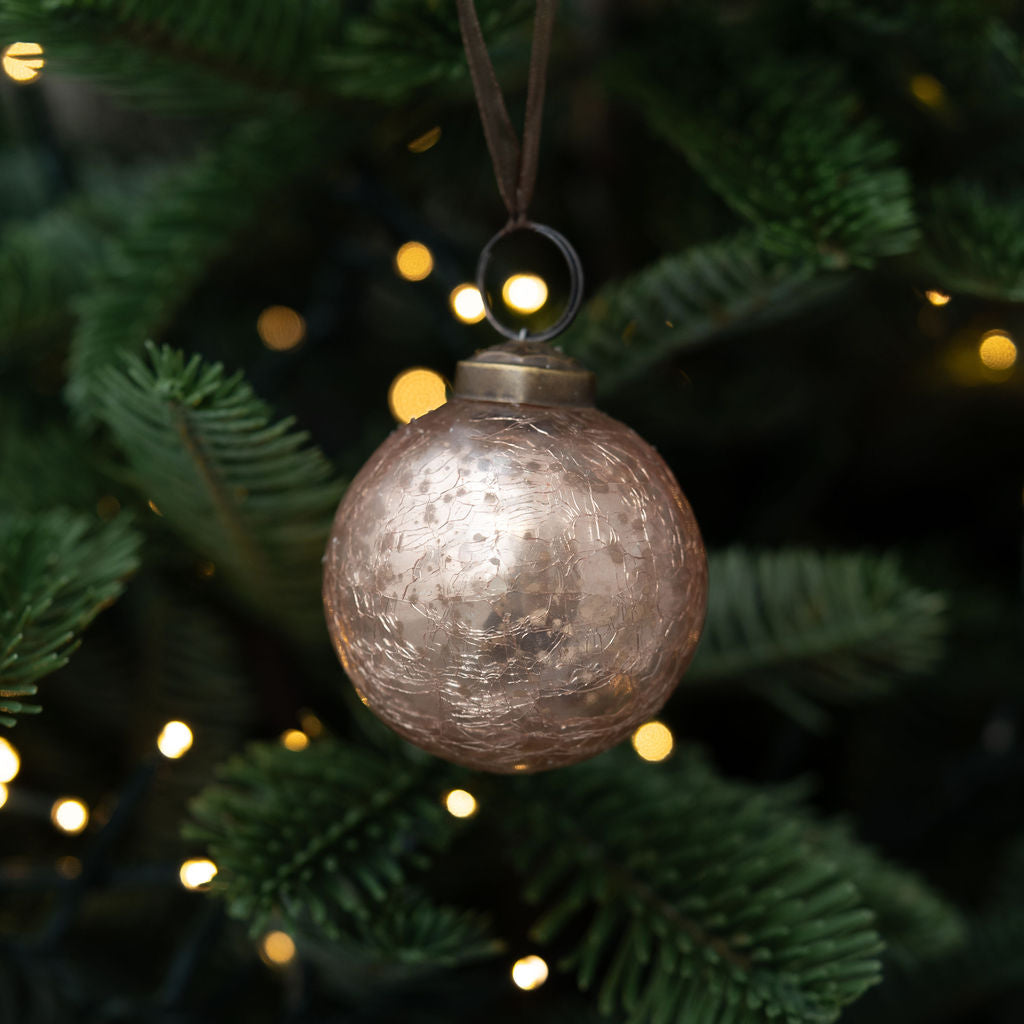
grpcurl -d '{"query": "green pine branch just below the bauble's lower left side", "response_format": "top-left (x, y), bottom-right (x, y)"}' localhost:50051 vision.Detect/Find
top-left (186, 740), bottom-right (494, 966)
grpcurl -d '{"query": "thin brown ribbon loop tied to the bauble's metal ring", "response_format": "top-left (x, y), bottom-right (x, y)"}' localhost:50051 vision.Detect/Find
top-left (456, 0), bottom-right (556, 223)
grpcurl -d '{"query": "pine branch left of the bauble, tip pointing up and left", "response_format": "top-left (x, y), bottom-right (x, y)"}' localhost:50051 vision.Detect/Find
top-left (99, 344), bottom-right (341, 639)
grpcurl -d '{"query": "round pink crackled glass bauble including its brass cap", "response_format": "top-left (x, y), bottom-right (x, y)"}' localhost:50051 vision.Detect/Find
top-left (324, 342), bottom-right (708, 772)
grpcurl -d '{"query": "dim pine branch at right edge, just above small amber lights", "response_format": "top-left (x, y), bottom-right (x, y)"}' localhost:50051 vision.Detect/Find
top-left (910, 181), bottom-right (1024, 302)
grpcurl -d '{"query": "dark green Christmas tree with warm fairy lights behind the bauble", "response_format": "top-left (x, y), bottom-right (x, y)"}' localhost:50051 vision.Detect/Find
top-left (0, 0), bottom-right (1024, 1024)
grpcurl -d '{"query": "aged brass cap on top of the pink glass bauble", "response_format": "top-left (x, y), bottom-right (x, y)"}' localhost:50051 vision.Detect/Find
top-left (455, 340), bottom-right (595, 406)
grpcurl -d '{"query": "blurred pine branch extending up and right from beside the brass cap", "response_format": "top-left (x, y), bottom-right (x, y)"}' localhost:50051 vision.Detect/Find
top-left (559, 232), bottom-right (846, 388)
